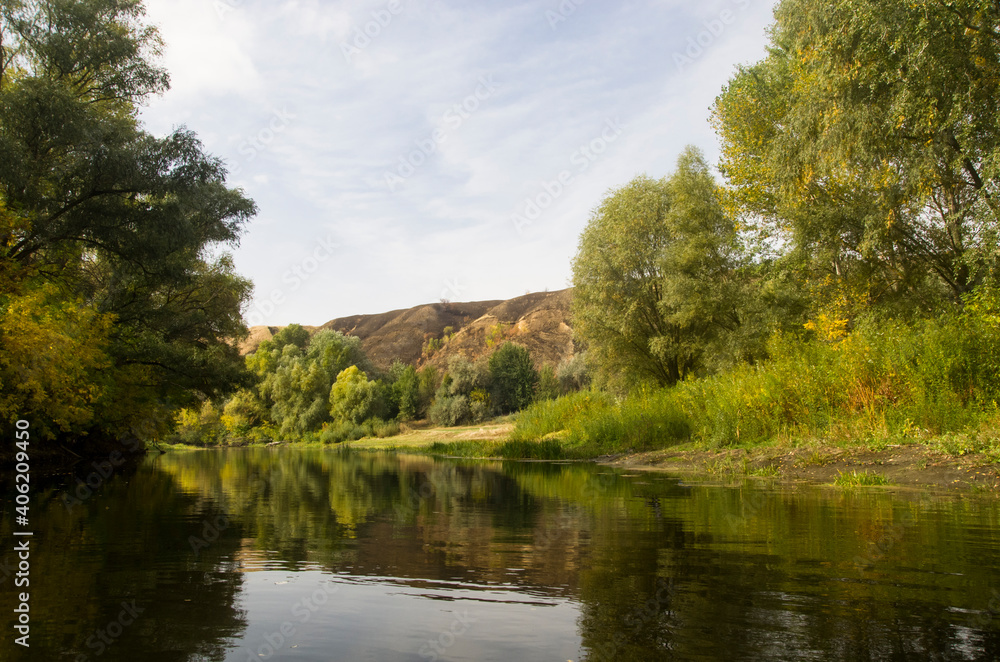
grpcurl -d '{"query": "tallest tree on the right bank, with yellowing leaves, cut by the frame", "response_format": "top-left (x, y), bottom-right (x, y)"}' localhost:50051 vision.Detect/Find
top-left (714, 0), bottom-right (1000, 318)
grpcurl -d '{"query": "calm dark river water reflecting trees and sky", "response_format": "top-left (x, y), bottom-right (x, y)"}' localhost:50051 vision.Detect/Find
top-left (0, 448), bottom-right (1000, 662)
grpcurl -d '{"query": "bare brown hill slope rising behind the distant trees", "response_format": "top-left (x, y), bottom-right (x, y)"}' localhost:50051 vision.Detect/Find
top-left (242, 289), bottom-right (574, 370)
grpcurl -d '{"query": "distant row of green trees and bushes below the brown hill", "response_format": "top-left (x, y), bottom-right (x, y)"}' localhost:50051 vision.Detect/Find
top-left (171, 324), bottom-right (587, 445)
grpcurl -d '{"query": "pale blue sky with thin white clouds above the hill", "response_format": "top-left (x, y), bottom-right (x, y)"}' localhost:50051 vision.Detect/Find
top-left (141, 0), bottom-right (774, 325)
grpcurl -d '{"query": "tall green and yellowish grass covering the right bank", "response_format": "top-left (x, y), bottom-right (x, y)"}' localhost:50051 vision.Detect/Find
top-left (511, 305), bottom-right (1000, 454)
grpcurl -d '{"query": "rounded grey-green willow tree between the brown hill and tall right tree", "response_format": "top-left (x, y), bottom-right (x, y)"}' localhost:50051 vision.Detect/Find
top-left (573, 148), bottom-right (753, 386)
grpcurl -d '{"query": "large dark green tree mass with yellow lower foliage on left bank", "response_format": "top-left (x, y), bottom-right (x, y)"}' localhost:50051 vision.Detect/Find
top-left (0, 0), bottom-right (255, 446)
